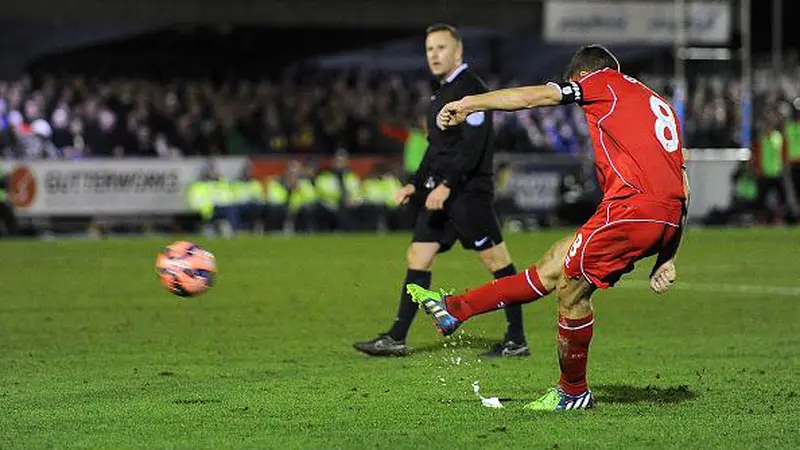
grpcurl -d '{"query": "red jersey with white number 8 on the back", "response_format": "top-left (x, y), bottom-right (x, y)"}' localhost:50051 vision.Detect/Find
top-left (573, 68), bottom-right (685, 200)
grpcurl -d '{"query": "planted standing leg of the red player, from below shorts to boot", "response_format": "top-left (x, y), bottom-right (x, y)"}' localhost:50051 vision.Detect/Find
top-left (525, 275), bottom-right (595, 411)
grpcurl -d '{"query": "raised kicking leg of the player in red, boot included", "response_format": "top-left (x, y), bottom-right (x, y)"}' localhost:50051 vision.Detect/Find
top-left (407, 236), bottom-right (574, 336)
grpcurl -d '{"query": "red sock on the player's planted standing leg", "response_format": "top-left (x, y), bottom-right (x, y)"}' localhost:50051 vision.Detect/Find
top-left (558, 314), bottom-right (594, 395)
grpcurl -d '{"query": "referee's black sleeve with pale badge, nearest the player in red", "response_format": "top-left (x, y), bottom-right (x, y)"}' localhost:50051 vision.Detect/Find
top-left (444, 111), bottom-right (490, 188)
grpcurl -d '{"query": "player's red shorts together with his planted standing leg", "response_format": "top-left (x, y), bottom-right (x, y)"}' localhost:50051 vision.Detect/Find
top-left (525, 196), bottom-right (683, 411)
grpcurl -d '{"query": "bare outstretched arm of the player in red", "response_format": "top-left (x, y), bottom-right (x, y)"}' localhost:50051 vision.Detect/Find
top-left (436, 85), bottom-right (561, 129)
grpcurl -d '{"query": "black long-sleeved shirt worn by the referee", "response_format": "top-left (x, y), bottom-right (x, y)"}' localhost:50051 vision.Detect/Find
top-left (414, 64), bottom-right (494, 191)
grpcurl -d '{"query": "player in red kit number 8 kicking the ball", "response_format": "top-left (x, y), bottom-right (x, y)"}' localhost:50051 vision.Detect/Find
top-left (408, 45), bottom-right (689, 411)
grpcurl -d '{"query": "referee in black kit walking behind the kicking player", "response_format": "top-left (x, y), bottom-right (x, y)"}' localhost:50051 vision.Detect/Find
top-left (354, 24), bottom-right (530, 356)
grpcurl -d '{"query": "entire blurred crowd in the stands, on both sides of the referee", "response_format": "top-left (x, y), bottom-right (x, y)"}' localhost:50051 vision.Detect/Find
top-left (0, 57), bottom-right (800, 158)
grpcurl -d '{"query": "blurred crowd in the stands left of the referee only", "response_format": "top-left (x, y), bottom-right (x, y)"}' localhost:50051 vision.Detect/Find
top-left (0, 70), bottom-right (430, 158)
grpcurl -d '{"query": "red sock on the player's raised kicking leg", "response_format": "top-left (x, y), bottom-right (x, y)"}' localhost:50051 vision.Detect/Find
top-left (446, 266), bottom-right (550, 322)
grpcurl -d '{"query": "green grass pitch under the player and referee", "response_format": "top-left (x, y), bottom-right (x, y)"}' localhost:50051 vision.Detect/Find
top-left (0, 229), bottom-right (800, 449)
